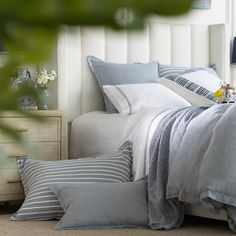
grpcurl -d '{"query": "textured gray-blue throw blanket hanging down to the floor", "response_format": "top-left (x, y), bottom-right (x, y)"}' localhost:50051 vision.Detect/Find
top-left (148, 107), bottom-right (208, 229)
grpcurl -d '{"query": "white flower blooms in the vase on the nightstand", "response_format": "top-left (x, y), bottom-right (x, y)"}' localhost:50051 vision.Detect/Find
top-left (35, 69), bottom-right (57, 88)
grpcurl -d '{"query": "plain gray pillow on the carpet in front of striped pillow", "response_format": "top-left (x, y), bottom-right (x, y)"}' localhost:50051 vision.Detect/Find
top-left (51, 180), bottom-right (148, 229)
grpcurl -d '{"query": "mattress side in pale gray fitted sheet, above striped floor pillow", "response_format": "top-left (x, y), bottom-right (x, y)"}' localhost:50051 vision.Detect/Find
top-left (69, 111), bottom-right (137, 158)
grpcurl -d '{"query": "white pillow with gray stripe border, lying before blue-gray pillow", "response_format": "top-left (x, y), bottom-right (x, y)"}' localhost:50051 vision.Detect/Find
top-left (103, 83), bottom-right (191, 116)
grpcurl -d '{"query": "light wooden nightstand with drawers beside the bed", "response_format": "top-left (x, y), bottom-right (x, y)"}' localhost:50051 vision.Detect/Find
top-left (0, 110), bottom-right (68, 201)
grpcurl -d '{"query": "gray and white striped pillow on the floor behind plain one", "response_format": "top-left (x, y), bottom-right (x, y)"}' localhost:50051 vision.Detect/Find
top-left (11, 141), bottom-right (132, 220)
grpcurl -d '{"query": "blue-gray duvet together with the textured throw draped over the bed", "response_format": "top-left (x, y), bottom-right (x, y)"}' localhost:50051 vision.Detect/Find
top-left (148, 104), bottom-right (236, 232)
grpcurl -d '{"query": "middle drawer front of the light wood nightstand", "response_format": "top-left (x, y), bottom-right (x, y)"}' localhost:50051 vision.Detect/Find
top-left (0, 142), bottom-right (61, 170)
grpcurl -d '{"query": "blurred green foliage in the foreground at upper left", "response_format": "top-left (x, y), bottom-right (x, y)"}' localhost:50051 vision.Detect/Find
top-left (0, 0), bottom-right (193, 139)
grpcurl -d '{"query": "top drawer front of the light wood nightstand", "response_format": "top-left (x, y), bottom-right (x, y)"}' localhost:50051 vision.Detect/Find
top-left (0, 117), bottom-right (61, 142)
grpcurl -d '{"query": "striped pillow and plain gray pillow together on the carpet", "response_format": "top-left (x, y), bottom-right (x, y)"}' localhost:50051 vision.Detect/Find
top-left (11, 141), bottom-right (148, 229)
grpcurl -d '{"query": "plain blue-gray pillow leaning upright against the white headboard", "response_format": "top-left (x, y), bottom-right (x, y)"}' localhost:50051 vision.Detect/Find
top-left (87, 56), bottom-right (159, 113)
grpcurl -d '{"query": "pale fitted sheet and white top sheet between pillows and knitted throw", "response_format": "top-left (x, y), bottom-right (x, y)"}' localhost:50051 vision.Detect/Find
top-left (69, 108), bottom-right (173, 180)
